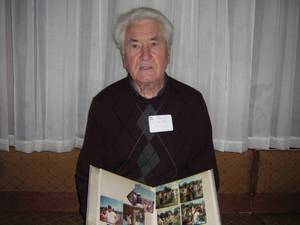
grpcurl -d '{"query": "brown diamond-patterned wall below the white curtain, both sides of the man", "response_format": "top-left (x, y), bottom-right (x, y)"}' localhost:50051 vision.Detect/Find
top-left (0, 148), bottom-right (300, 213)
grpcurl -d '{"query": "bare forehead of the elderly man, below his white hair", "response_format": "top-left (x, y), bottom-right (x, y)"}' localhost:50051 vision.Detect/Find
top-left (125, 20), bottom-right (164, 41)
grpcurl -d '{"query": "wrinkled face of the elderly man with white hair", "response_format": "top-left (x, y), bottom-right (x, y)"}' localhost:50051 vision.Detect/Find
top-left (121, 20), bottom-right (171, 84)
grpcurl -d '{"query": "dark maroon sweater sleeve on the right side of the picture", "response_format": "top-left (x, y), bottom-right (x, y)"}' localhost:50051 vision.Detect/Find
top-left (189, 98), bottom-right (219, 190)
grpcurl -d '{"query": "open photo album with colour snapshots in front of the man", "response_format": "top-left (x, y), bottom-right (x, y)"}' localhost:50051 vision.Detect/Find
top-left (86, 166), bottom-right (221, 225)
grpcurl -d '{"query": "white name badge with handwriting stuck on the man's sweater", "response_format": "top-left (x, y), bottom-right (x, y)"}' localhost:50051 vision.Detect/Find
top-left (148, 115), bottom-right (173, 133)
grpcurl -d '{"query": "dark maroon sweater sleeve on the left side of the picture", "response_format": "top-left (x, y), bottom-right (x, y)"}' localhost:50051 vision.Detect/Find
top-left (75, 99), bottom-right (103, 219)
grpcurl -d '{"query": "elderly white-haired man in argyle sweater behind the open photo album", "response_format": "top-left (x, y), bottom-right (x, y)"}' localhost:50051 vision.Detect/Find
top-left (76, 8), bottom-right (219, 216)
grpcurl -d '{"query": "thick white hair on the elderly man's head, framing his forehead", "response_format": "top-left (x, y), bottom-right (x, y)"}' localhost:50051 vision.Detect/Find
top-left (114, 7), bottom-right (174, 50)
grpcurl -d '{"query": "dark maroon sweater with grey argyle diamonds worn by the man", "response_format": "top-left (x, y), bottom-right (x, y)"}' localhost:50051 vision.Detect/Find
top-left (76, 75), bottom-right (219, 217)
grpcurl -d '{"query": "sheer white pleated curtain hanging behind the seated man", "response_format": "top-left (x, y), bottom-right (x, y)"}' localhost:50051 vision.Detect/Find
top-left (0, 0), bottom-right (300, 153)
